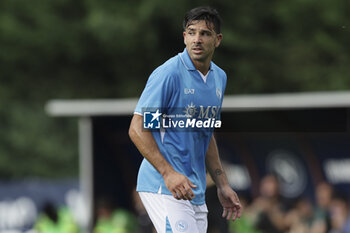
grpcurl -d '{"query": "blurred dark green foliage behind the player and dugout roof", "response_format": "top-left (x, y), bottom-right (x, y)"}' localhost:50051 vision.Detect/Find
top-left (0, 0), bottom-right (350, 179)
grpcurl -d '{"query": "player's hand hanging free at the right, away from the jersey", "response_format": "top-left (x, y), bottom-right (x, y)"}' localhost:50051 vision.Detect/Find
top-left (218, 186), bottom-right (242, 221)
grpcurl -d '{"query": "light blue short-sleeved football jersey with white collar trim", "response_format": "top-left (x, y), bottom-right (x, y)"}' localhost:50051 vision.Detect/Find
top-left (135, 48), bottom-right (227, 205)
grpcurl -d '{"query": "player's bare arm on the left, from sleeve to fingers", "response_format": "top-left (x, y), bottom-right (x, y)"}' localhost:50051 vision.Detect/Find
top-left (129, 114), bottom-right (196, 200)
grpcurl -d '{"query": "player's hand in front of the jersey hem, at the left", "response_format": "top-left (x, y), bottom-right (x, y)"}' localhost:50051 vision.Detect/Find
top-left (163, 170), bottom-right (197, 200)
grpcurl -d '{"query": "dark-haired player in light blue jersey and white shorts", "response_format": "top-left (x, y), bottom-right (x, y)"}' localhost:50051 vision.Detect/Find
top-left (129, 7), bottom-right (241, 233)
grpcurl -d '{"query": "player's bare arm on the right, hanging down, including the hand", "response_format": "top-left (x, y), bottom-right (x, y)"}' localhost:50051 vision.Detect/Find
top-left (206, 135), bottom-right (242, 221)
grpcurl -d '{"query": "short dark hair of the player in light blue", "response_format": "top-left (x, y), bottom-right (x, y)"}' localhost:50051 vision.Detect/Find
top-left (183, 6), bottom-right (221, 33)
